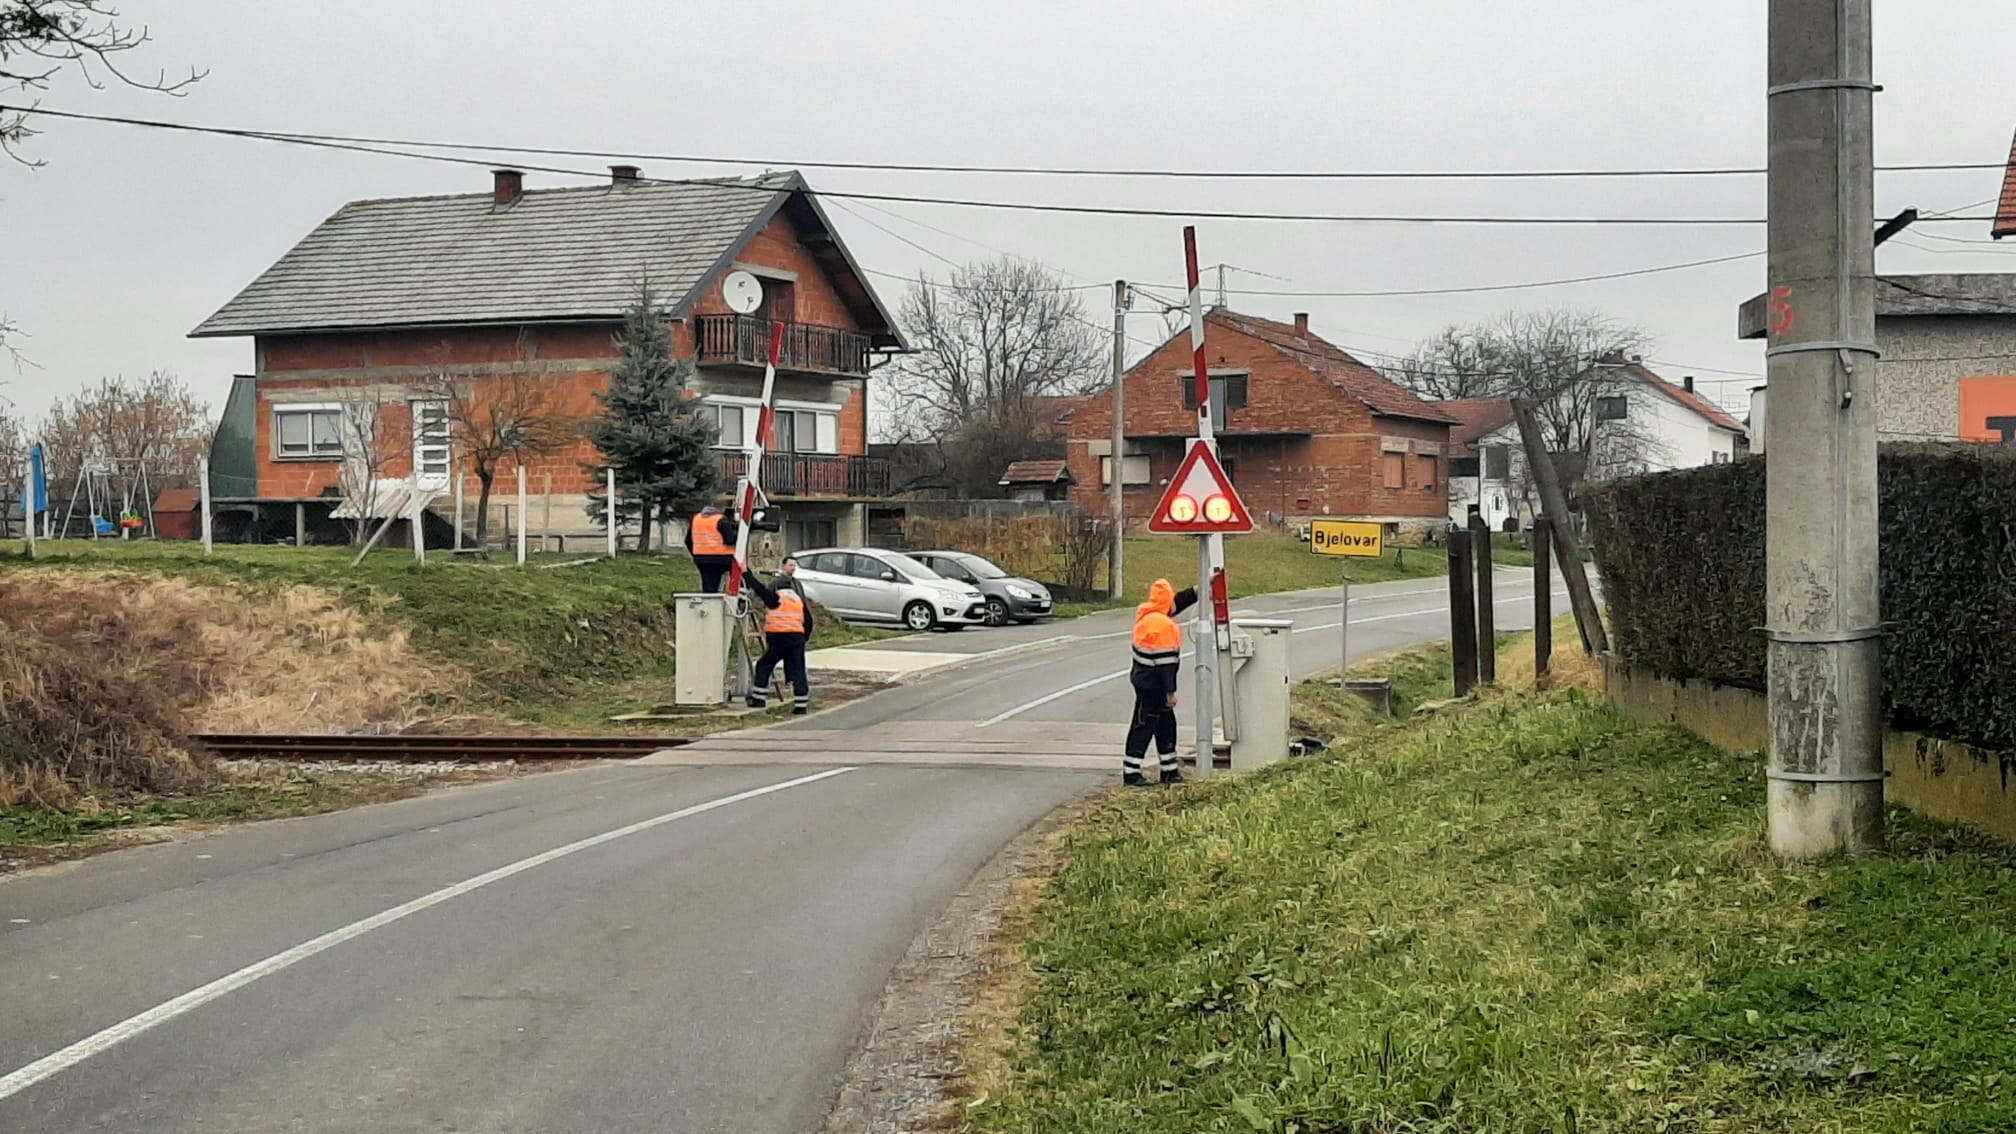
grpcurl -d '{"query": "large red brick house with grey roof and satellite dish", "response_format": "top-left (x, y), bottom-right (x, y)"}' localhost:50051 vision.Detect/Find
top-left (192, 165), bottom-right (903, 545)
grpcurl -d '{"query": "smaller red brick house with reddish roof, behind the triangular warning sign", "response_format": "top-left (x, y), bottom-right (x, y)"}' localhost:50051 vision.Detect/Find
top-left (1068, 309), bottom-right (1454, 533)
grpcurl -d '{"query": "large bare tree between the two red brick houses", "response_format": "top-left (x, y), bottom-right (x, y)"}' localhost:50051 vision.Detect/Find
top-left (889, 256), bottom-right (1111, 494)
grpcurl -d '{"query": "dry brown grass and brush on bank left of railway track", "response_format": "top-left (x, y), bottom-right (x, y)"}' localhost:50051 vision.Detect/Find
top-left (0, 571), bottom-right (464, 805)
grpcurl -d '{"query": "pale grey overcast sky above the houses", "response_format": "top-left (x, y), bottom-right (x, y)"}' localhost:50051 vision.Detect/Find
top-left (0, 0), bottom-right (2016, 416)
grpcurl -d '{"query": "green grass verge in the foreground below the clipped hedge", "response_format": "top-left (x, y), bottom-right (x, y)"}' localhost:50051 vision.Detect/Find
top-left (966, 677), bottom-right (2016, 1134)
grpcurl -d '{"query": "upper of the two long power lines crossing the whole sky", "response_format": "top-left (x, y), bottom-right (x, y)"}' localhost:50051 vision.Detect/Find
top-left (0, 107), bottom-right (2008, 182)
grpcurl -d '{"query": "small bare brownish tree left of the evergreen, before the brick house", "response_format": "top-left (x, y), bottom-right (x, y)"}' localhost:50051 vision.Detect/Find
top-left (427, 373), bottom-right (587, 549)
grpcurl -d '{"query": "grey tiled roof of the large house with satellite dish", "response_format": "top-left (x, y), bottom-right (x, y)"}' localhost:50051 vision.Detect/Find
top-left (190, 174), bottom-right (804, 337)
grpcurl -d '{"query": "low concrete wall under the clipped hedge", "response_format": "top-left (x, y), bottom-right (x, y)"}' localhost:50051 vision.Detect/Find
top-left (1607, 662), bottom-right (2016, 841)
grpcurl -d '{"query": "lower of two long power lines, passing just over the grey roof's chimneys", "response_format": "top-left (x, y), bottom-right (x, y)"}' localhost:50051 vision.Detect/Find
top-left (0, 105), bottom-right (1994, 228)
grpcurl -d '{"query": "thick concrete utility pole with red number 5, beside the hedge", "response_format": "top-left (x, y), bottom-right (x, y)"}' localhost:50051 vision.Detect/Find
top-left (1764, 0), bottom-right (1883, 858)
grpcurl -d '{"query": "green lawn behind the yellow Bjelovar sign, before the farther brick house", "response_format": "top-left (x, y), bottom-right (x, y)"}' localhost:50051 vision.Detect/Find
top-left (1056, 535), bottom-right (1450, 617)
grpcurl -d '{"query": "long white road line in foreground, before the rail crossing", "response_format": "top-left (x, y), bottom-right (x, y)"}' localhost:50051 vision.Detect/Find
top-left (0, 767), bottom-right (855, 1100)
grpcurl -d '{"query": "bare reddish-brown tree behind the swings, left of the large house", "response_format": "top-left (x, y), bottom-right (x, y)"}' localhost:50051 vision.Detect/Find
top-left (40, 369), bottom-right (214, 488)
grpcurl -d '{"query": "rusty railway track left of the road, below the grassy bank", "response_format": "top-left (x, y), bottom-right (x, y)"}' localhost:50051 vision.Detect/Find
top-left (192, 732), bottom-right (694, 765)
